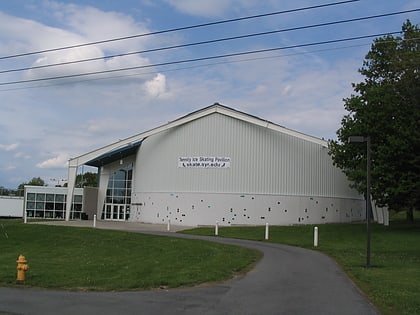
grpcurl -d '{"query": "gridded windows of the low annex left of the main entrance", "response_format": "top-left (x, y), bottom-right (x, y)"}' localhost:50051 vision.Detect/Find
top-left (25, 187), bottom-right (83, 219)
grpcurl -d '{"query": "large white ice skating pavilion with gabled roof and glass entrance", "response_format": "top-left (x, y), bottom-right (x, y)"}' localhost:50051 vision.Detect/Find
top-left (66, 103), bottom-right (365, 226)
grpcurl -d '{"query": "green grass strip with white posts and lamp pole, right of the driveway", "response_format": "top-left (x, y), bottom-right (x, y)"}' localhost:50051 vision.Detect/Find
top-left (183, 217), bottom-right (420, 315)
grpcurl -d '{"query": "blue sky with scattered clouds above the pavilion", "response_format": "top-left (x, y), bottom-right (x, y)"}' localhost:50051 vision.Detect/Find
top-left (0, 0), bottom-right (420, 188)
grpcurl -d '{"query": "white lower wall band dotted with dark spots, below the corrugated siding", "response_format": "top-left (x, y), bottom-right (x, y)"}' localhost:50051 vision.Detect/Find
top-left (129, 193), bottom-right (365, 226)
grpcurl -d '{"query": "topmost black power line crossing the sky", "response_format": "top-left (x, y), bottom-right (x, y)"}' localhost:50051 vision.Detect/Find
top-left (0, 0), bottom-right (360, 60)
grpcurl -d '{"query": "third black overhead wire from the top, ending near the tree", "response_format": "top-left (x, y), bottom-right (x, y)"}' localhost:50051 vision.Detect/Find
top-left (0, 31), bottom-right (401, 86)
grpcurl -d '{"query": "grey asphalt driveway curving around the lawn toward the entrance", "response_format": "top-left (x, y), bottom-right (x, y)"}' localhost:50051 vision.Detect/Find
top-left (0, 225), bottom-right (378, 315)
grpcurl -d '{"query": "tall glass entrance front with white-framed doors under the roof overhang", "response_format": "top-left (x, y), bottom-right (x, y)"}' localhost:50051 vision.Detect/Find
top-left (102, 164), bottom-right (133, 220)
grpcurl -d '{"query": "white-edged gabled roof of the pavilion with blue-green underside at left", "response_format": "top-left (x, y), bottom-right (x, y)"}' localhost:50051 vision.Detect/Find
top-left (69, 103), bottom-right (328, 167)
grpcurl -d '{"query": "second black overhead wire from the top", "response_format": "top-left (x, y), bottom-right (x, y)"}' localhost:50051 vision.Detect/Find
top-left (0, 9), bottom-right (420, 74)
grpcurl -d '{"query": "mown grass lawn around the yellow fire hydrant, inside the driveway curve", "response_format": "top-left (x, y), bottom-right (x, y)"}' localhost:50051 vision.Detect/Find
top-left (0, 220), bottom-right (261, 290)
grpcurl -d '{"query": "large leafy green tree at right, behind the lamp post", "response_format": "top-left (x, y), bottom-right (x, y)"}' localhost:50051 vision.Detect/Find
top-left (329, 21), bottom-right (420, 220)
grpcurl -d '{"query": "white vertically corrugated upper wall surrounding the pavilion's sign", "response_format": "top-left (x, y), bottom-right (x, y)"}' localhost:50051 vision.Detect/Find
top-left (134, 113), bottom-right (360, 198)
